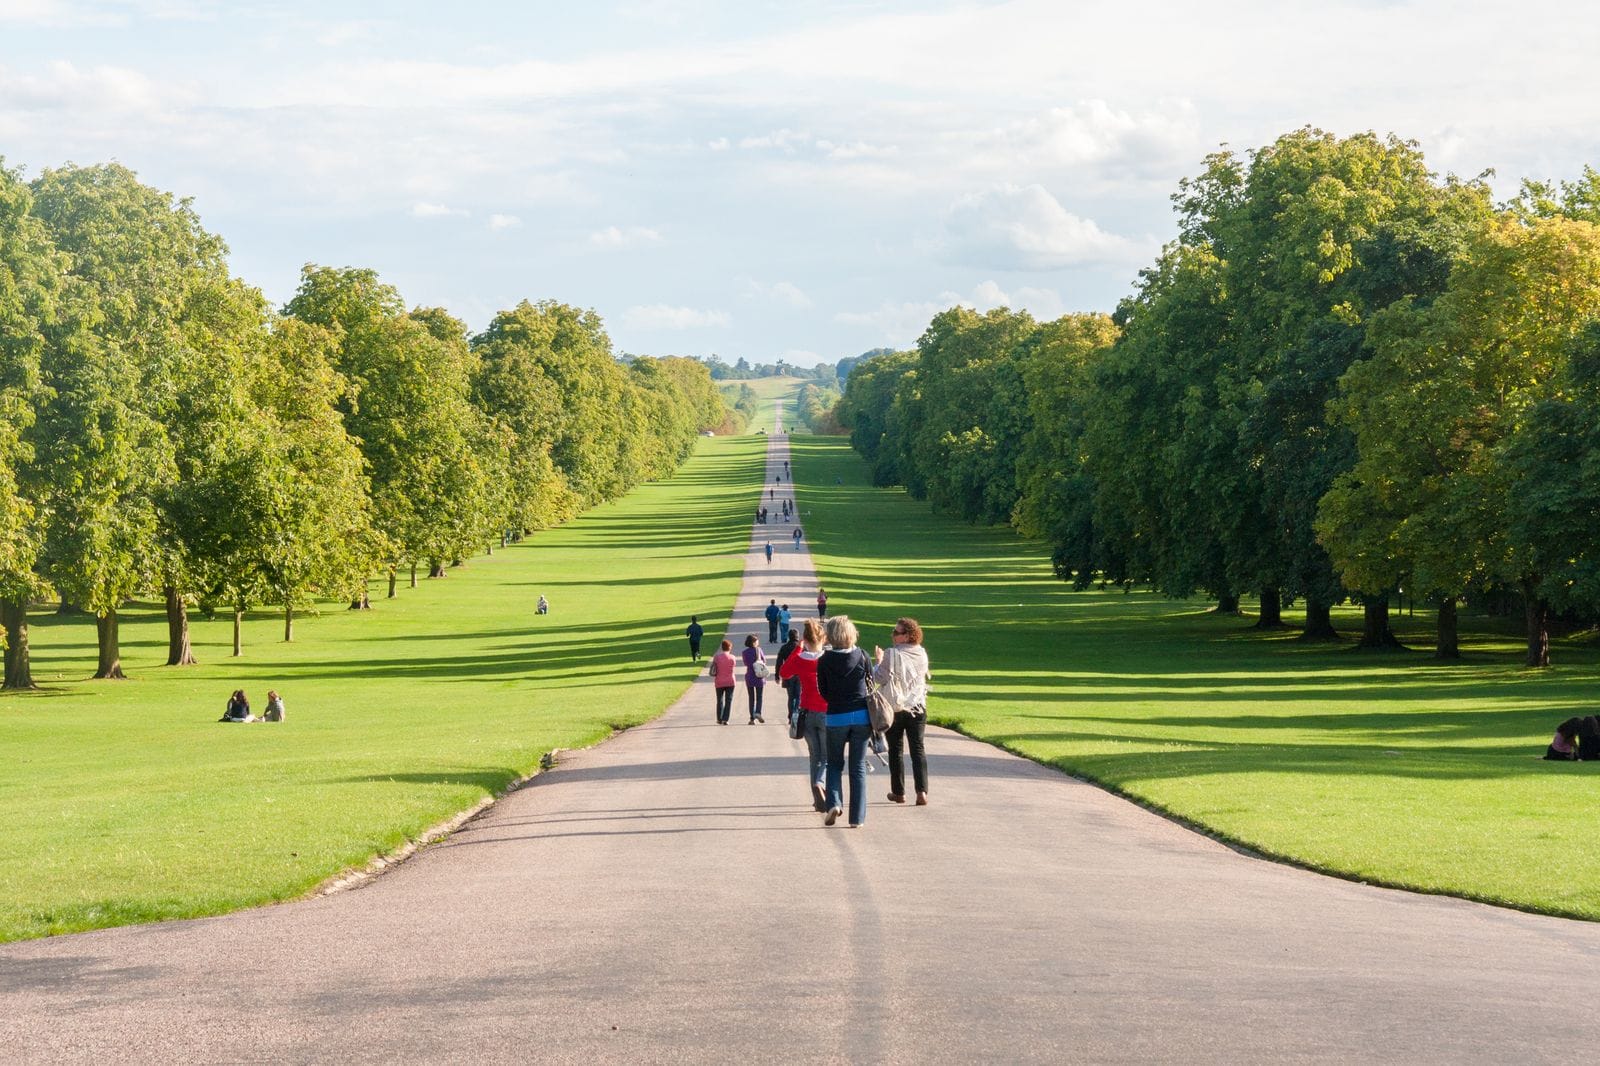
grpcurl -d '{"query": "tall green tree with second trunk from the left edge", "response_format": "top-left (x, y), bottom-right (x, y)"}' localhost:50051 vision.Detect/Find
top-left (34, 165), bottom-right (226, 677)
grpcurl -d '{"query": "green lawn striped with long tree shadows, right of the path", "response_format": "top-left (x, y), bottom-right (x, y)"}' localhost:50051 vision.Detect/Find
top-left (792, 437), bottom-right (1600, 919)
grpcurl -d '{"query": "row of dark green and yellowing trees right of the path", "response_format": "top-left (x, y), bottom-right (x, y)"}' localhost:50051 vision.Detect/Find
top-left (838, 128), bottom-right (1600, 666)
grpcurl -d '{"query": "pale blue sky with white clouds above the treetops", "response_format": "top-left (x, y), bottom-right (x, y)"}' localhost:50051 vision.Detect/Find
top-left (0, 0), bottom-right (1600, 365)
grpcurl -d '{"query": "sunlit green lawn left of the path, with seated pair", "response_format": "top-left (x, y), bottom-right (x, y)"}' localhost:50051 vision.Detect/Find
top-left (0, 425), bottom-right (770, 941)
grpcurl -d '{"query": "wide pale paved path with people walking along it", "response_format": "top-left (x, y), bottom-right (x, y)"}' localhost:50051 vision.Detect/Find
top-left (0, 409), bottom-right (1600, 1063)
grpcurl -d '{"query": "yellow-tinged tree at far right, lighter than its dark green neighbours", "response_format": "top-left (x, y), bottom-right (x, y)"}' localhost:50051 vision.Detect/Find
top-left (1322, 214), bottom-right (1600, 666)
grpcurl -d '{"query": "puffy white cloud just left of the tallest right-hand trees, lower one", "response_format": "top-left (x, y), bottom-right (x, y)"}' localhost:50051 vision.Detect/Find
top-left (942, 184), bottom-right (1136, 271)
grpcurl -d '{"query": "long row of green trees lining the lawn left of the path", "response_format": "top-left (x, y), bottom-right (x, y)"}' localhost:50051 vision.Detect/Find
top-left (0, 165), bottom-right (725, 688)
